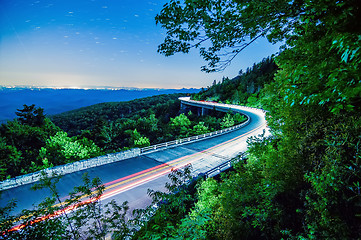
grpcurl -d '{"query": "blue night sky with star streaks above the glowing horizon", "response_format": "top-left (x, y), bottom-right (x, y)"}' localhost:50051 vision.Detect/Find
top-left (0, 0), bottom-right (278, 88)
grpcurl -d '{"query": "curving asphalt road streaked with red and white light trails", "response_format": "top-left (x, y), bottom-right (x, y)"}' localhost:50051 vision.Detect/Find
top-left (0, 103), bottom-right (267, 218)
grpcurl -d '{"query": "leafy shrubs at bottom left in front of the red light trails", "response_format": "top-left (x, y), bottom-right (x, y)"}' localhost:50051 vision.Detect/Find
top-left (0, 174), bottom-right (135, 240)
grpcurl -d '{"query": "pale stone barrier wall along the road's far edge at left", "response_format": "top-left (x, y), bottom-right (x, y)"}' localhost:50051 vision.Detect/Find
top-left (0, 148), bottom-right (140, 191)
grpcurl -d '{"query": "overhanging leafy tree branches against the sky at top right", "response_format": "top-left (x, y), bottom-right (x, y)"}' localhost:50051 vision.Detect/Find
top-left (156, 0), bottom-right (361, 71)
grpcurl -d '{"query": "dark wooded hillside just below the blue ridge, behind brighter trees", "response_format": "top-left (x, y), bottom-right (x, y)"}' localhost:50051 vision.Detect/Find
top-left (51, 94), bottom-right (185, 136)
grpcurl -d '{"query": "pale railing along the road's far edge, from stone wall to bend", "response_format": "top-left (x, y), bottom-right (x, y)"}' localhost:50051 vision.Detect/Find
top-left (140, 116), bottom-right (250, 153)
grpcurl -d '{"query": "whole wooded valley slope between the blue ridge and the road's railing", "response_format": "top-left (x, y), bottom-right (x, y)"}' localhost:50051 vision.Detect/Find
top-left (48, 94), bottom-right (228, 152)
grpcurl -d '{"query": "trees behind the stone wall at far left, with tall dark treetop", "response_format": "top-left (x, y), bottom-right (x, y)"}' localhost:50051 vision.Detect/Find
top-left (0, 105), bottom-right (103, 180)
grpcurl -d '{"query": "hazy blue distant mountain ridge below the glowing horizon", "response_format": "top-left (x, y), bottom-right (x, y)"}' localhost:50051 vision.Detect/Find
top-left (0, 86), bottom-right (199, 122)
